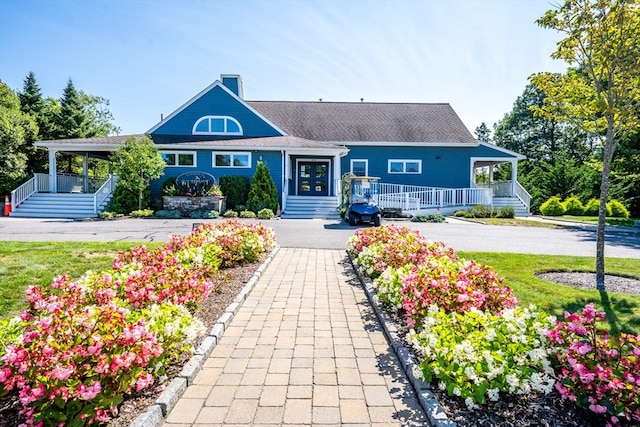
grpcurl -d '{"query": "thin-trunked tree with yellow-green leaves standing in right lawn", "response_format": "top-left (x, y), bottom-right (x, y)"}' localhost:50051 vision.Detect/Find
top-left (532, 0), bottom-right (640, 290)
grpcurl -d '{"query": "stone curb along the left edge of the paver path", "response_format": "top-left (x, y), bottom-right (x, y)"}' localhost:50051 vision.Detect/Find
top-left (128, 245), bottom-right (280, 427)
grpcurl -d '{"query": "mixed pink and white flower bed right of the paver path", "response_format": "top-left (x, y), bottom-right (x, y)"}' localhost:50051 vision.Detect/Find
top-left (347, 226), bottom-right (640, 425)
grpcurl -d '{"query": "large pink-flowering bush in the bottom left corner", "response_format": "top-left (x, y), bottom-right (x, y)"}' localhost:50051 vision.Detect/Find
top-left (0, 276), bottom-right (162, 425)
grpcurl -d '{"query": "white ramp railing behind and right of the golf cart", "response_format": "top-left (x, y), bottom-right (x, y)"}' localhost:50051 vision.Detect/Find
top-left (352, 183), bottom-right (491, 213)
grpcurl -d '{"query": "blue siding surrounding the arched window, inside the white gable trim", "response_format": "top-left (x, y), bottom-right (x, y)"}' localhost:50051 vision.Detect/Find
top-left (152, 86), bottom-right (282, 140)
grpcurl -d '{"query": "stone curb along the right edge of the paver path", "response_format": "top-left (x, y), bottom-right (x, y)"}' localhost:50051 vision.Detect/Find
top-left (347, 251), bottom-right (456, 427)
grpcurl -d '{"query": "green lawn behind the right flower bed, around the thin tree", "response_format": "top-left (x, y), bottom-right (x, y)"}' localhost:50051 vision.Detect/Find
top-left (458, 252), bottom-right (640, 335)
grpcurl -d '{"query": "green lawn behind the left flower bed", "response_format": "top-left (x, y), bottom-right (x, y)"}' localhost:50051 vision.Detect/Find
top-left (0, 241), bottom-right (160, 318)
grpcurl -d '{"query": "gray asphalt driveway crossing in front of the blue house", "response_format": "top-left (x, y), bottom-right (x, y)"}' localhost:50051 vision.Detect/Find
top-left (0, 217), bottom-right (640, 259)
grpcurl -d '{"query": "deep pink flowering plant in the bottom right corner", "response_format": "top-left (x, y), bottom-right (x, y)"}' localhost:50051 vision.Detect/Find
top-left (547, 303), bottom-right (640, 425)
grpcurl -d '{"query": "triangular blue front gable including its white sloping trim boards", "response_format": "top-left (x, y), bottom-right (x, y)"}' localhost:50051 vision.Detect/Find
top-left (147, 80), bottom-right (285, 139)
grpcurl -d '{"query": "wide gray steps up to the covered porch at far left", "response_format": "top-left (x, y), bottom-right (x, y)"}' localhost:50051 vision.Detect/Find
top-left (9, 193), bottom-right (111, 218)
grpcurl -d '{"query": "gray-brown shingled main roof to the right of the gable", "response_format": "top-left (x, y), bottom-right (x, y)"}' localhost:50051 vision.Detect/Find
top-left (246, 101), bottom-right (476, 143)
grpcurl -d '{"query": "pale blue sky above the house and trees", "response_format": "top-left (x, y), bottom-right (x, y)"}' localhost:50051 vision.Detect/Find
top-left (0, 0), bottom-right (566, 134)
